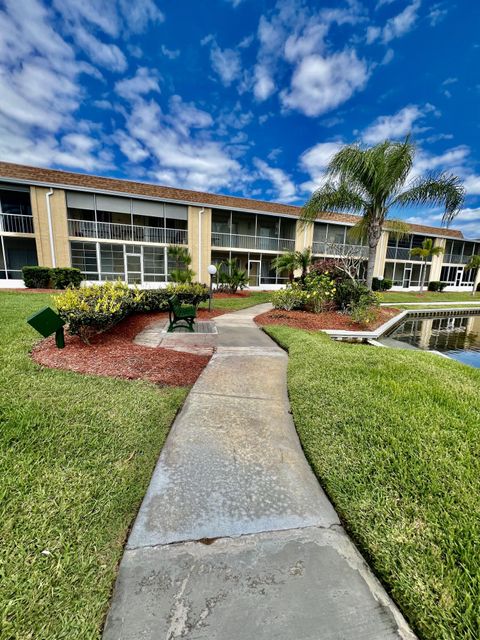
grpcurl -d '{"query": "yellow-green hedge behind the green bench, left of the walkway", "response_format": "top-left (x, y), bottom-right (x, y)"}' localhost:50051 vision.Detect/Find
top-left (54, 281), bottom-right (209, 343)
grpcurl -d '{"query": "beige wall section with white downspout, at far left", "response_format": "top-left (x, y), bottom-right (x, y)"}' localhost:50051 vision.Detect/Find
top-left (30, 187), bottom-right (71, 267)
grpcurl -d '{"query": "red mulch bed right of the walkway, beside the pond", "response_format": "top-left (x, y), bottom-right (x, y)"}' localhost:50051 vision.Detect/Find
top-left (255, 307), bottom-right (399, 331)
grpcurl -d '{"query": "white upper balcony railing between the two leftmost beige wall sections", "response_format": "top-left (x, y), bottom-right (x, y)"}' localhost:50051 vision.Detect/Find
top-left (68, 220), bottom-right (188, 244)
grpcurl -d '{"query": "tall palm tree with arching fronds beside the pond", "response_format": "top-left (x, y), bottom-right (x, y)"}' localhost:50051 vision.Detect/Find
top-left (300, 141), bottom-right (465, 289)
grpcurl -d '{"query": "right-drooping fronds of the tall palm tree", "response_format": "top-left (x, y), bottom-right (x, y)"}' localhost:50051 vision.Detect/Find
top-left (391, 173), bottom-right (465, 226)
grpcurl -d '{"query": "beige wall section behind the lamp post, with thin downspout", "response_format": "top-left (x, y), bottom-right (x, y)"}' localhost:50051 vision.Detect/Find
top-left (188, 207), bottom-right (212, 284)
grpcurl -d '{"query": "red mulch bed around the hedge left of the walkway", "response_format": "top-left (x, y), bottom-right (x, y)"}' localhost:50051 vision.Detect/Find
top-left (32, 310), bottom-right (224, 386)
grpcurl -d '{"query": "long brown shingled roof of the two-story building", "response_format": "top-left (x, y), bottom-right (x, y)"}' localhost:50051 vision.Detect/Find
top-left (0, 162), bottom-right (463, 239)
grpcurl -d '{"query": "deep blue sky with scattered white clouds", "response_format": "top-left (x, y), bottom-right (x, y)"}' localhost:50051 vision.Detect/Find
top-left (0, 0), bottom-right (480, 237)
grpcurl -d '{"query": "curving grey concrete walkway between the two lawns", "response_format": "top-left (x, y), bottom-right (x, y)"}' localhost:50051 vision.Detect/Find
top-left (104, 305), bottom-right (414, 640)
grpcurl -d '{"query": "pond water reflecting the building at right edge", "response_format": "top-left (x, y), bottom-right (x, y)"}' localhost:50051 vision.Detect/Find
top-left (389, 313), bottom-right (480, 368)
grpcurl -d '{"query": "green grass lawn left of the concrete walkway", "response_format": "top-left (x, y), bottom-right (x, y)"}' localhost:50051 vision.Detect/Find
top-left (0, 292), bottom-right (187, 640)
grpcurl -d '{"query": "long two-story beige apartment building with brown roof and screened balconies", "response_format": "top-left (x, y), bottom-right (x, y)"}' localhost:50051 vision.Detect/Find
top-left (0, 162), bottom-right (480, 290)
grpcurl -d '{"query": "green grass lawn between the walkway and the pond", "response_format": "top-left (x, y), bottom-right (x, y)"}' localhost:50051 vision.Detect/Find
top-left (268, 326), bottom-right (480, 640)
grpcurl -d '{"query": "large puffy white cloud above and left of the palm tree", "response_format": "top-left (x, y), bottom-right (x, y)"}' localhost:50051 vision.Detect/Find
top-left (280, 50), bottom-right (369, 116)
